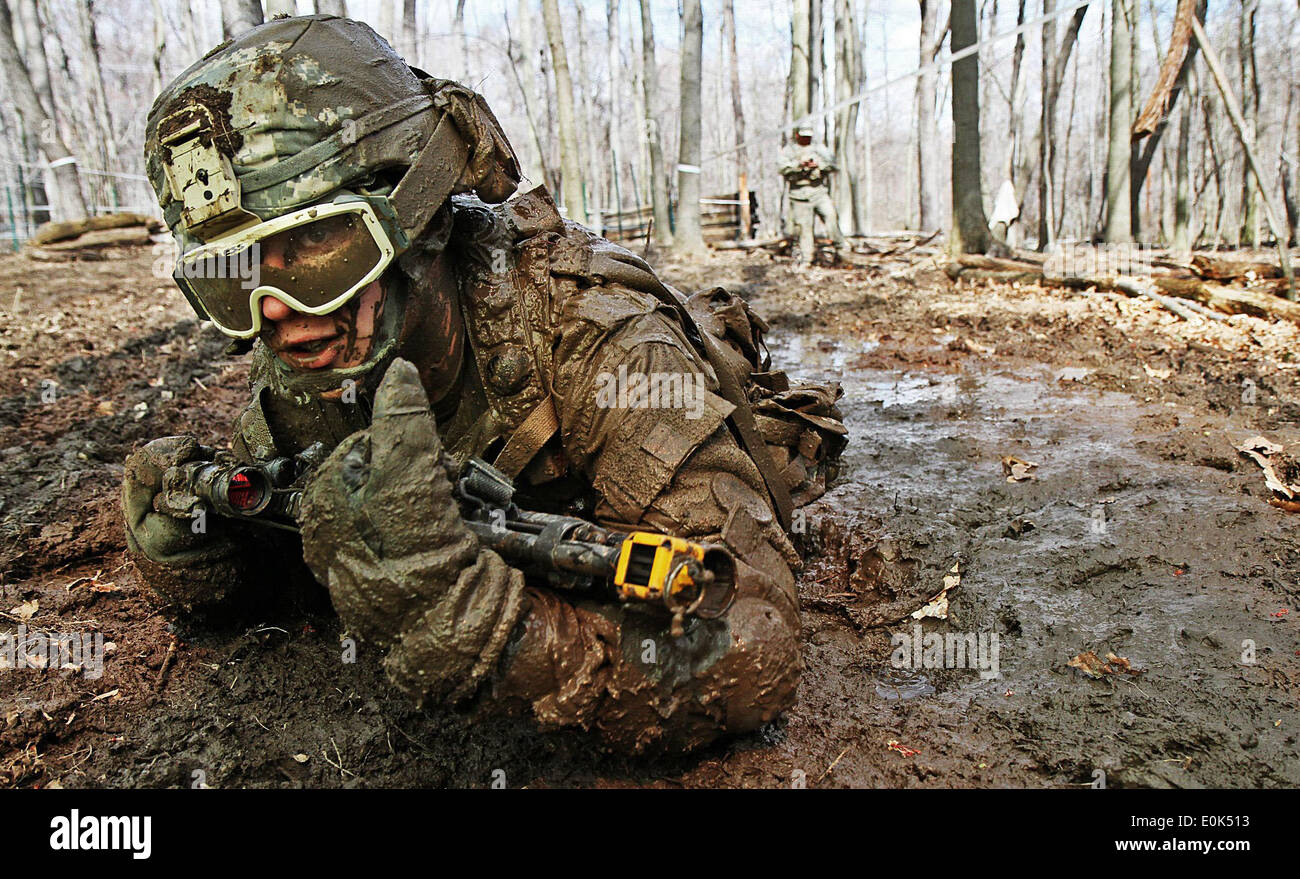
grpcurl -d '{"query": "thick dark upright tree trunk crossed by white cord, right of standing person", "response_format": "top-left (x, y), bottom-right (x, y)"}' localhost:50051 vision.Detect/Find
top-left (949, 0), bottom-right (988, 254)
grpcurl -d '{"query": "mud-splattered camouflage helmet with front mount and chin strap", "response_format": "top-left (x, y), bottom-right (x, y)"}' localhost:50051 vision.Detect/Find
top-left (144, 16), bottom-right (520, 393)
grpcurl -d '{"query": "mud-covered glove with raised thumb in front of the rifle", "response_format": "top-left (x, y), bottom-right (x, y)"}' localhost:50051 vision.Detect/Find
top-left (300, 359), bottom-right (525, 700)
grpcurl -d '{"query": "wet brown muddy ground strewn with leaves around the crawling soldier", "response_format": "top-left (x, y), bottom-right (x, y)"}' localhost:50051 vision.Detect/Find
top-left (0, 241), bottom-right (1300, 788)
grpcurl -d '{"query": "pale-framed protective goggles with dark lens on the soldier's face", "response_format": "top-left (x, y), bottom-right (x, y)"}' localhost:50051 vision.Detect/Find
top-left (173, 194), bottom-right (408, 339)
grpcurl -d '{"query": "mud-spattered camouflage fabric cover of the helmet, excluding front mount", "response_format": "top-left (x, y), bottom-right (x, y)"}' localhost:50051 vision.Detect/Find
top-left (144, 16), bottom-right (519, 238)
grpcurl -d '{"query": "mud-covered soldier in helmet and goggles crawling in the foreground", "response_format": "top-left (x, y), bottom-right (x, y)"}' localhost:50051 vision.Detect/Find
top-left (122, 16), bottom-right (844, 753)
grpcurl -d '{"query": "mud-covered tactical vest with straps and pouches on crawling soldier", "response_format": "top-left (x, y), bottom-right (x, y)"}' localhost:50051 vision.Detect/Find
top-left (235, 187), bottom-right (846, 527)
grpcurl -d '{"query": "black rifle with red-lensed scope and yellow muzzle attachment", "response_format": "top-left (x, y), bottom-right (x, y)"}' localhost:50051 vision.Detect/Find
top-left (155, 443), bottom-right (736, 637)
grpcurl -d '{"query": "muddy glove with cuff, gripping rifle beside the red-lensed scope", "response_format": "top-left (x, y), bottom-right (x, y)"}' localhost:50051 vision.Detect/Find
top-left (122, 437), bottom-right (239, 610)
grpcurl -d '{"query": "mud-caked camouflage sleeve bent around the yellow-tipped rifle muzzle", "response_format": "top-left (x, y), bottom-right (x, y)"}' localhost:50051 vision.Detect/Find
top-left (499, 286), bottom-right (800, 753)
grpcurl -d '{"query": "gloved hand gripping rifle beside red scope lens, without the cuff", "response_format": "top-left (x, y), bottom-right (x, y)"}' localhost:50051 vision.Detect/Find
top-left (122, 437), bottom-right (230, 564)
